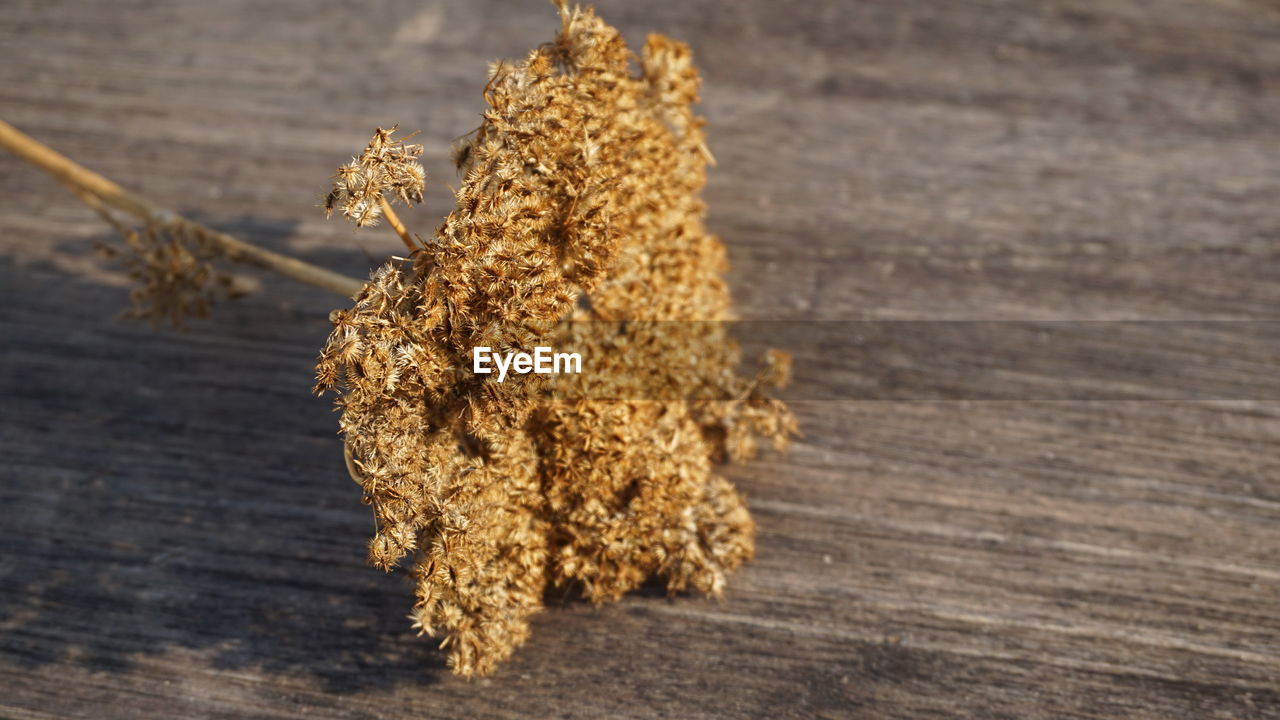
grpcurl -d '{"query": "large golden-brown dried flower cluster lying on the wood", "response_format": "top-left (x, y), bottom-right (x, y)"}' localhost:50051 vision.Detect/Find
top-left (316, 5), bottom-right (795, 676)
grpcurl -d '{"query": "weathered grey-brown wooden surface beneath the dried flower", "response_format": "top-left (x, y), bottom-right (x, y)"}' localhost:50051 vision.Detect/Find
top-left (0, 0), bottom-right (1280, 719)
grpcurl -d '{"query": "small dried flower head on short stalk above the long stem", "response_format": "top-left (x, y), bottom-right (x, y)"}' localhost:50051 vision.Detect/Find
top-left (324, 126), bottom-right (426, 228)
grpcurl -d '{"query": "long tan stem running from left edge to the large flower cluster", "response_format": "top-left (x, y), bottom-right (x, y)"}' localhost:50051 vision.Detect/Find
top-left (0, 120), bottom-right (365, 297)
